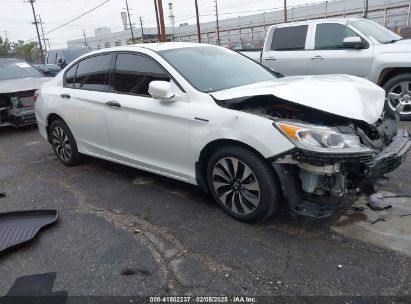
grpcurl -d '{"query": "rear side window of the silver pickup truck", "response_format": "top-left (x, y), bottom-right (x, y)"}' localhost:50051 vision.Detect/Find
top-left (271, 25), bottom-right (308, 51)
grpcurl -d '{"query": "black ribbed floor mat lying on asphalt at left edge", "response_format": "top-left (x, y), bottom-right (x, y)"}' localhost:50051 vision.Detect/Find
top-left (0, 210), bottom-right (58, 254)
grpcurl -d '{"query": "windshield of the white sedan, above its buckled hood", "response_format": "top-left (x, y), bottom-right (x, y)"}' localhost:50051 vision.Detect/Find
top-left (159, 46), bottom-right (276, 93)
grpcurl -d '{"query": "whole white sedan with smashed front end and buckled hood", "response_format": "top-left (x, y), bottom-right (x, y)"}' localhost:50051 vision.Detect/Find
top-left (35, 43), bottom-right (411, 221)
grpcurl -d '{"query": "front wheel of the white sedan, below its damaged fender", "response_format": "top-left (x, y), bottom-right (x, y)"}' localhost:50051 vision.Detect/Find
top-left (206, 145), bottom-right (281, 222)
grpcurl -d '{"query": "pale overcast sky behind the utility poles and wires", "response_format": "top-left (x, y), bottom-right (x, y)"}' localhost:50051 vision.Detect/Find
top-left (0, 0), bottom-right (332, 48)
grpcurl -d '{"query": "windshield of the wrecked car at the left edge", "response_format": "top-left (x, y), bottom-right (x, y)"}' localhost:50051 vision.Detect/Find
top-left (0, 59), bottom-right (42, 80)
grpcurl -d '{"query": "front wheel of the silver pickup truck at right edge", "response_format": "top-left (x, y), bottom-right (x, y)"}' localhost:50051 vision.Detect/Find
top-left (383, 73), bottom-right (411, 120)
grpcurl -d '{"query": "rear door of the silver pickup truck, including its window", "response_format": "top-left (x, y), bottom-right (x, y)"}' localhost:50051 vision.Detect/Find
top-left (262, 24), bottom-right (309, 76)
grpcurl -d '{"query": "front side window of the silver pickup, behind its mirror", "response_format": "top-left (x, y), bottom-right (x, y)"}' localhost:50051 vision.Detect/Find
top-left (315, 23), bottom-right (359, 50)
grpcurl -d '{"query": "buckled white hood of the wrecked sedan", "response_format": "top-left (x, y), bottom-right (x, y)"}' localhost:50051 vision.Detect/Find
top-left (211, 75), bottom-right (385, 124)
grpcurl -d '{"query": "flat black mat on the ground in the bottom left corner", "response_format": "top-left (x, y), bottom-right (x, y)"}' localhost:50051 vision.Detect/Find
top-left (0, 272), bottom-right (67, 304)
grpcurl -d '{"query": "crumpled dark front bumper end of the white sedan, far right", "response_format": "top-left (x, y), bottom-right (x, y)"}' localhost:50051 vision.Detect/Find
top-left (364, 129), bottom-right (411, 177)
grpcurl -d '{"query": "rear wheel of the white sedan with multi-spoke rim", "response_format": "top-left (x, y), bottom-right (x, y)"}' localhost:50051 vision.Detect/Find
top-left (50, 119), bottom-right (83, 167)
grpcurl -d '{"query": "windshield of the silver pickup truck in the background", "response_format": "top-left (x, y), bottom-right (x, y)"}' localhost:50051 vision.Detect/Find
top-left (350, 19), bottom-right (402, 43)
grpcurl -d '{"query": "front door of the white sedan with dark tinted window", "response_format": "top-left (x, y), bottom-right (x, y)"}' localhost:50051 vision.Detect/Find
top-left (106, 53), bottom-right (192, 179)
